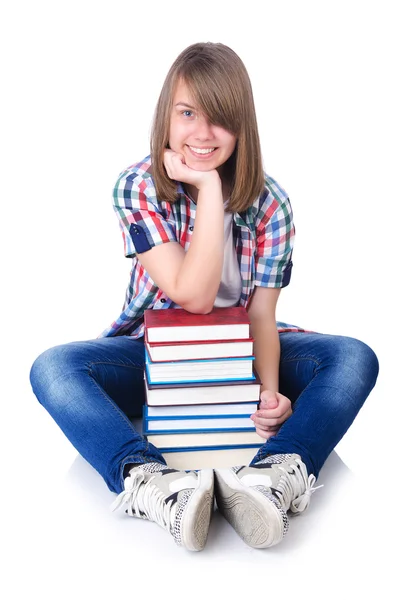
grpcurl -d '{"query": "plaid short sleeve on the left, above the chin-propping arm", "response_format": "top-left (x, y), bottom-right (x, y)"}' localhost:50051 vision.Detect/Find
top-left (113, 172), bottom-right (177, 258)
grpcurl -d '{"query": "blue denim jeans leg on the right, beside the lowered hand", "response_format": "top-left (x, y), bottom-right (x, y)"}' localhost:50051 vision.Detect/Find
top-left (251, 332), bottom-right (379, 477)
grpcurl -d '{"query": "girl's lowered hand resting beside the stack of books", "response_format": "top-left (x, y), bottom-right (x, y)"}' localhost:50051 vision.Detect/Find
top-left (250, 390), bottom-right (292, 440)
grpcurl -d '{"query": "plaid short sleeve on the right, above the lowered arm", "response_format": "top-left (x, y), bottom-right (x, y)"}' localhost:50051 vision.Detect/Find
top-left (254, 180), bottom-right (295, 288)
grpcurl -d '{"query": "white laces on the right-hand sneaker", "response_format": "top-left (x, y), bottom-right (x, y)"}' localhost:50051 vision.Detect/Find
top-left (274, 459), bottom-right (323, 513)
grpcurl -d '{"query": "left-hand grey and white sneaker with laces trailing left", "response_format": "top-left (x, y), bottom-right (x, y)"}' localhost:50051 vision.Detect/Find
top-left (111, 463), bottom-right (214, 550)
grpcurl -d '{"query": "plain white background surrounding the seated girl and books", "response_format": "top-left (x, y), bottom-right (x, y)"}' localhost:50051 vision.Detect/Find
top-left (0, 0), bottom-right (397, 599)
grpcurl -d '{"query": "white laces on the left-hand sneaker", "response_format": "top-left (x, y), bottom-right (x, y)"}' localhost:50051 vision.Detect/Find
top-left (111, 471), bottom-right (173, 532)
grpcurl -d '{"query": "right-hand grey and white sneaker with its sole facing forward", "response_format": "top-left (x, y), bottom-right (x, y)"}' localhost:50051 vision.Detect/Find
top-left (215, 454), bottom-right (322, 548)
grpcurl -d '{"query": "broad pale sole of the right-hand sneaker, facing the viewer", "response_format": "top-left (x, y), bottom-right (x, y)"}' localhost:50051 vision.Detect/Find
top-left (215, 469), bottom-right (288, 548)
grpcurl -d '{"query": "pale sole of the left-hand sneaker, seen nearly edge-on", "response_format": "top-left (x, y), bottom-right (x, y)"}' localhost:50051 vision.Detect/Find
top-left (181, 469), bottom-right (214, 552)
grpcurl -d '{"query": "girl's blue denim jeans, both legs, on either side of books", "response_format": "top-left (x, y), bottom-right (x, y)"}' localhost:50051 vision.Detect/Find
top-left (30, 332), bottom-right (379, 493)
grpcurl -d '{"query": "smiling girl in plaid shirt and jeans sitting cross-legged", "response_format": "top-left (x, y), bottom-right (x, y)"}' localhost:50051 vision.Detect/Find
top-left (31, 43), bottom-right (378, 550)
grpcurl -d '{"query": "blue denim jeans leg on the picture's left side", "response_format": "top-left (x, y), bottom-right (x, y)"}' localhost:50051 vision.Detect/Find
top-left (30, 336), bottom-right (165, 493)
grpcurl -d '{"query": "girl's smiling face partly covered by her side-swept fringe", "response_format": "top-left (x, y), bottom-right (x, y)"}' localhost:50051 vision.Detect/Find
top-left (169, 80), bottom-right (237, 171)
